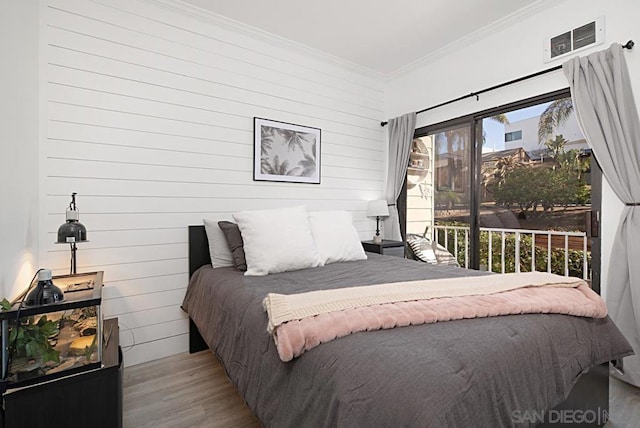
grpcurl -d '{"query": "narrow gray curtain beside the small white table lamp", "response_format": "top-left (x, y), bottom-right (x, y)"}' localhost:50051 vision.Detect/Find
top-left (383, 113), bottom-right (416, 241)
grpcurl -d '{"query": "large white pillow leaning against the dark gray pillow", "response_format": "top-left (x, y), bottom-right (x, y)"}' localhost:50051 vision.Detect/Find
top-left (233, 206), bottom-right (322, 276)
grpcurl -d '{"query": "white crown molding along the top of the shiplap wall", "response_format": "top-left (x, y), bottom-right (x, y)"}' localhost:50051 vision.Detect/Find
top-left (141, 0), bottom-right (386, 80)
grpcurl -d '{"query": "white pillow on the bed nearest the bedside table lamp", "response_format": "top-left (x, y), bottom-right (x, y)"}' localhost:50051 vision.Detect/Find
top-left (309, 211), bottom-right (367, 264)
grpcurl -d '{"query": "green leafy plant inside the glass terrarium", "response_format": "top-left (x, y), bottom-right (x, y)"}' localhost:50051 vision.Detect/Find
top-left (0, 299), bottom-right (60, 363)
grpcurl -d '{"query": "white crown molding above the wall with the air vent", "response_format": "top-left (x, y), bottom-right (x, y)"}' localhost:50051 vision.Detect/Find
top-left (385, 0), bottom-right (566, 82)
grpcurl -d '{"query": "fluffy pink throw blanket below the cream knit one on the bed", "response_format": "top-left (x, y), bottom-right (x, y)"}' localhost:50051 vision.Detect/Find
top-left (273, 283), bottom-right (607, 362)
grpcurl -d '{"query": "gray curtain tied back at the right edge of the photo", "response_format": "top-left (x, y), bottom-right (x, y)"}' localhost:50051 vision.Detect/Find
top-left (563, 44), bottom-right (640, 386)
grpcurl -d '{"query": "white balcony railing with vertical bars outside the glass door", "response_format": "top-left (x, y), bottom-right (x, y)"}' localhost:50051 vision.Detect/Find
top-left (431, 225), bottom-right (591, 280)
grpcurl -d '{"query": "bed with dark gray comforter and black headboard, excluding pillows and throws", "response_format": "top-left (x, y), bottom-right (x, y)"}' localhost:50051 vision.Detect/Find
top-left (183, 226), bottom-right (631, 428)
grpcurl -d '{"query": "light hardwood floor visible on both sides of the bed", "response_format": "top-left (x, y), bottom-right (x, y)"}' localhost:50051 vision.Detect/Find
top-left (124, 351), bottom-right (640, 428)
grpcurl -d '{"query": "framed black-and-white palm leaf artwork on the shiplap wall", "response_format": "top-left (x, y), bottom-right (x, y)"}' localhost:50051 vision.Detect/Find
top-left (253, 117), bottom-right (321, 184)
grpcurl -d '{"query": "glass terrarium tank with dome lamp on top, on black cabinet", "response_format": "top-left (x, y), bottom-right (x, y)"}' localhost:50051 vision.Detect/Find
top-left (0, 272), bottom-right (103, 389)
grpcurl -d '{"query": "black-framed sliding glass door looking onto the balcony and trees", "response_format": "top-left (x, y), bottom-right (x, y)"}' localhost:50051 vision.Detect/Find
top-left (406, 91), bottom-right (599, 279)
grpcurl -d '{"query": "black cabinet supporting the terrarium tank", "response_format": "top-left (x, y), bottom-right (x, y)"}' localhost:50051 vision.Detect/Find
top-left (2, 318), bottom-right (123, 428)
